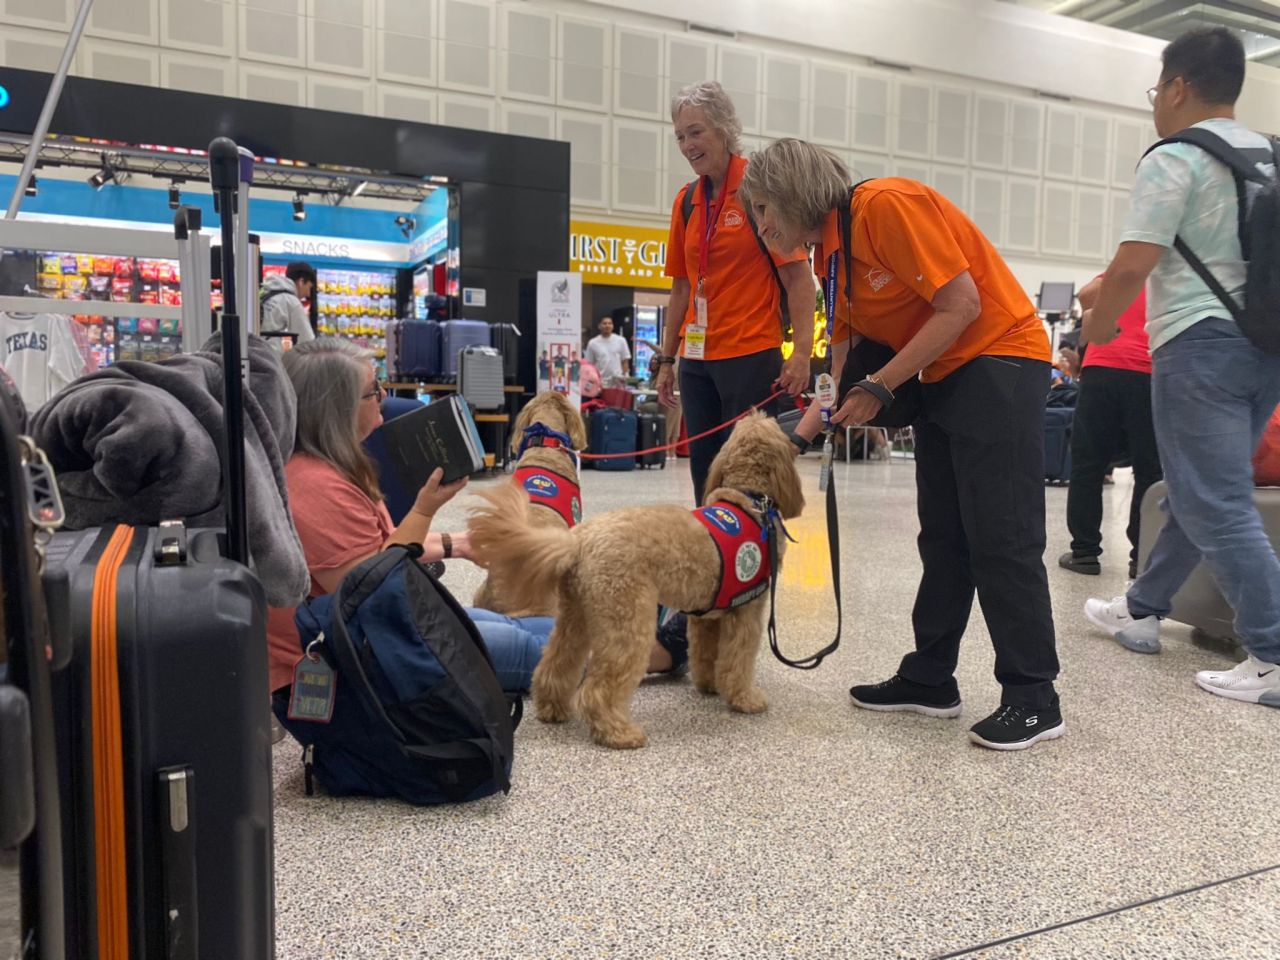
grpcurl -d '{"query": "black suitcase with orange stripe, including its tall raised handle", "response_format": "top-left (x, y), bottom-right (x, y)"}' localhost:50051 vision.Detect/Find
top-left (0, 140), bottom-right (275, 960)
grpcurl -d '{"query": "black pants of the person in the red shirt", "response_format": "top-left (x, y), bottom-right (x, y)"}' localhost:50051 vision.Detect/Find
top-left (1066, 366), bottom-right (1164, 561)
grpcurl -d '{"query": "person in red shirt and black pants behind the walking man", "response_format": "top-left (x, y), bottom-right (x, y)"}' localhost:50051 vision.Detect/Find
top-left (1057, 276), bottom-right (1164, 580)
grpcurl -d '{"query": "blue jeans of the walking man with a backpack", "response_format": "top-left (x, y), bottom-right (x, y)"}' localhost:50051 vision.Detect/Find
top-left (1128, 319), bottom-right (1280, 663)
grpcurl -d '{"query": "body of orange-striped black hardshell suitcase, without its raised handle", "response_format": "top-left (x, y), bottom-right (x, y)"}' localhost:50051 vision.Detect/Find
top-left (45, 525), bottom-right (275, 960)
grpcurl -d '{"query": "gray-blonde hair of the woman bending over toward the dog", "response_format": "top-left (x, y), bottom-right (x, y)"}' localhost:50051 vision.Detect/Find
top-left (739, 140), bottom-right (852, 250)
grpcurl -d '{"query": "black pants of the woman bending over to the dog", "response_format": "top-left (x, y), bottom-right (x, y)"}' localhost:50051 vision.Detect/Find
top-left (899, 357), bottom-right (1057, 707)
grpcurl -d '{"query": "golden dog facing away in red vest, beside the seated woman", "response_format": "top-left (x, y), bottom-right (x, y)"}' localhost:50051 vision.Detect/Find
top-left (471, 390), bottom-right (586, 617)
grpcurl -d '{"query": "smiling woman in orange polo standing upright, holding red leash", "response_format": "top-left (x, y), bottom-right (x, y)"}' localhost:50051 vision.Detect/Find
top-left (654, 82), bottom-right (814, 503)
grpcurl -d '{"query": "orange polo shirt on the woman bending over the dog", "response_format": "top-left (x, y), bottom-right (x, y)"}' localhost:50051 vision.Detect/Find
top-left (813, 177), bottom-right (1050, 383)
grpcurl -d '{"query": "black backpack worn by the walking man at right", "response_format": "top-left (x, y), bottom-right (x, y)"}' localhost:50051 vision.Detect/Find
top-left (1143, 127), bottom-right (1280, 355)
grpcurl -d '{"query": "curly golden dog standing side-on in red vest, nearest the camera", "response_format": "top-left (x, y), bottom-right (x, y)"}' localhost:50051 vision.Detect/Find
top-left (467, 413), bottom-right (804, 749)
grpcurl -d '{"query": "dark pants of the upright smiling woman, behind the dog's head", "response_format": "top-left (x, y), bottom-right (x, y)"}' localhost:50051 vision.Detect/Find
top-left (680, 349), bottom-right (782, 506)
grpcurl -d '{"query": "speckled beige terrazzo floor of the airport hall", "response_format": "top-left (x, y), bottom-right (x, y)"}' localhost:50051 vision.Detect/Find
top-left (275, 456), bottom-right (1280, 960)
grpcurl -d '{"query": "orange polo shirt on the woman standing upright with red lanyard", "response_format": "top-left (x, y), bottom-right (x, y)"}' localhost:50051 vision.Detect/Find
top-left (666, 156), bottom-right (808, 360)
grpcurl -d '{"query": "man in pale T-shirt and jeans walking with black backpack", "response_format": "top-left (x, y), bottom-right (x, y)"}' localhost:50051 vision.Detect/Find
top-left (1083, 27), bottom-right (1280, 707)
